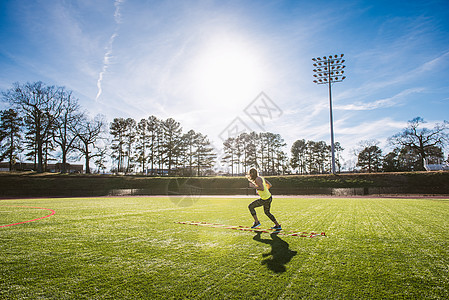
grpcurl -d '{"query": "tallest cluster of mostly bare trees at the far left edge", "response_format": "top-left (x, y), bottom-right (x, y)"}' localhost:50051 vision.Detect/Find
top-left (0, 82), bottom-right (104, 172)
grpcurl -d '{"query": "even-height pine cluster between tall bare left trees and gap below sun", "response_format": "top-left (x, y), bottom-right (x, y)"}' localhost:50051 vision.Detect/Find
top-left (109, 116), bottom-right (216, 176)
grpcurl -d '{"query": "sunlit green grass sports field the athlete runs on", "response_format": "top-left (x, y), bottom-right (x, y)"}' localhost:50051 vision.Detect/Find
top-left (0, 197), bottom-right (449, 299)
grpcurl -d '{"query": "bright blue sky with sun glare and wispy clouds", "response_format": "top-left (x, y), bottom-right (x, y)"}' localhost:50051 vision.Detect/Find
top-left (0, 0), bottom-right (449, 169)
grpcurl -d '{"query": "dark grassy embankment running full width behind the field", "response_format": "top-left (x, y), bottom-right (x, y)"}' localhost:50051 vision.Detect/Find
top-left (0, 172), bottom-right (449, 197)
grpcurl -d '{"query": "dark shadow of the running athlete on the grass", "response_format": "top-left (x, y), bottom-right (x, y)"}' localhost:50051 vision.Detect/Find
top-left (253, 232), bottom-right (297, 273)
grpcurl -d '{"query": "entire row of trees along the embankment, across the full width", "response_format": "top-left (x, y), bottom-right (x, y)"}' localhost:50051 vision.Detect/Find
top-left (0, 82), bottom-right (449, 176)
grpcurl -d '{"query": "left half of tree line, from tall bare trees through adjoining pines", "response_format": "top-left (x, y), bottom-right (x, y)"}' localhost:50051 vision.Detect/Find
top-left (0, 82), bottom-right (216, 176)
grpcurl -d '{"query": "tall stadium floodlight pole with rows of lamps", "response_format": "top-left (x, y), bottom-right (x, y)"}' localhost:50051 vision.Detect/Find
top-left (312, 54), bottom-right (346, 174)
